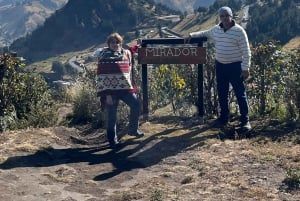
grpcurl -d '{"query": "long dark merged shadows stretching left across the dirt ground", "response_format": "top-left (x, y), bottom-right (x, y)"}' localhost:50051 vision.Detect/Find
top-left (0, 118), bottom-right (218, 181)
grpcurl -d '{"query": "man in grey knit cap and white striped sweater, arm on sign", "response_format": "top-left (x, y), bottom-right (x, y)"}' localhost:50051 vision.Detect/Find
top-left (185, 6), bottom-right (251, 130)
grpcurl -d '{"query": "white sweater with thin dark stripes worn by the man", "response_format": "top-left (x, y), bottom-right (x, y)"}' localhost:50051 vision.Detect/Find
top-left (190, 21), bottom-right (251, 70)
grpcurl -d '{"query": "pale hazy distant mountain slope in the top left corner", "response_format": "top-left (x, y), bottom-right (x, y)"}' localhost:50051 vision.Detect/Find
top-left (0, 0), bottom-right (68, 46)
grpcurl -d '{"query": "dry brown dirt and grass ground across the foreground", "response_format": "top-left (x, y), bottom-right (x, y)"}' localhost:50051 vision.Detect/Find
top-left (0, 117), bottom-right (300, 201)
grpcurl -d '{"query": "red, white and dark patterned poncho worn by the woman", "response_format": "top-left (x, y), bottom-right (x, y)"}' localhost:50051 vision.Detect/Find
top-left (97, 48), bottom-right (136, 97)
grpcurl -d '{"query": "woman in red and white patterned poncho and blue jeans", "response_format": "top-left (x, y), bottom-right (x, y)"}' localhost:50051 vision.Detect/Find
top-left (97, 33), bottom-right (144, 148)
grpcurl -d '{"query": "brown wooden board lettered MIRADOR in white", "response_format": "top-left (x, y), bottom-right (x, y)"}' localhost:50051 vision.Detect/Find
top-left (138, 47), bottom-right (206, 64)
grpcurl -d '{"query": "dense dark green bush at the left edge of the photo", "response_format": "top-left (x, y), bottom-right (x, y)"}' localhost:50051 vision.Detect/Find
top-left (0, 53), bottom-right (57, 132)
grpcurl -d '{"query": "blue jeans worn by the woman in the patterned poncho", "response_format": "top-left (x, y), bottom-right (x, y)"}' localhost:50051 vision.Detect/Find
top-left (106, 93), bottom-right (140, 144)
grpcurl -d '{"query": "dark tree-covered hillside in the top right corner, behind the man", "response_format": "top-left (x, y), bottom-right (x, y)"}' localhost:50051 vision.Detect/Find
top-left (247, 0), bottom-right (300, 45)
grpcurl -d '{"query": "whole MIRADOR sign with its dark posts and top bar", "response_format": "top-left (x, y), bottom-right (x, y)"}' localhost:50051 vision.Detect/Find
top-left (138, 37), bottom-right (207, 121)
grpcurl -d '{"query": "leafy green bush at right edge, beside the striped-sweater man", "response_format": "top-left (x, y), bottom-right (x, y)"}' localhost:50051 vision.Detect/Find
top-left (248, 41), bottom-right (300, 120)
